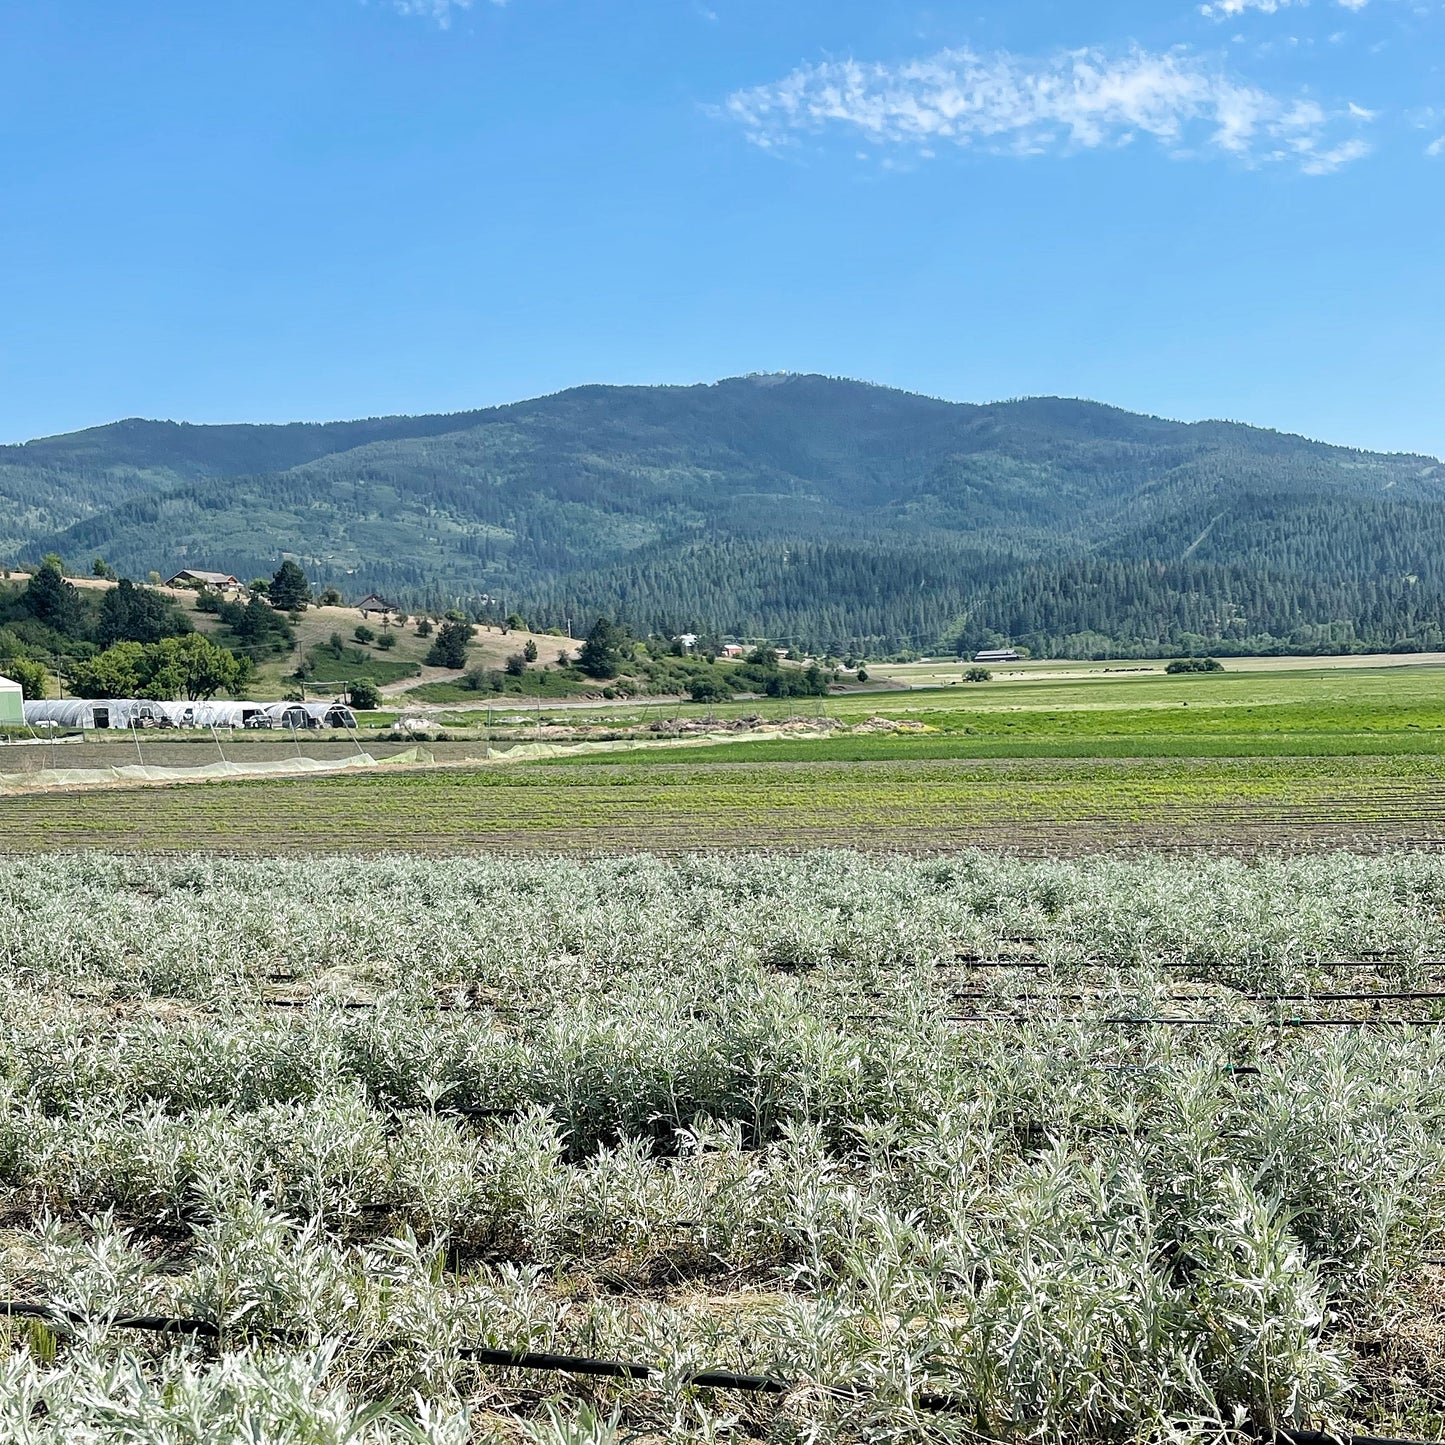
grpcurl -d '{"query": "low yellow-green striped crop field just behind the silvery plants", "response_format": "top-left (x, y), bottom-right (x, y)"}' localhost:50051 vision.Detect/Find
top-left (8, 743), bottom-right (1445, 855)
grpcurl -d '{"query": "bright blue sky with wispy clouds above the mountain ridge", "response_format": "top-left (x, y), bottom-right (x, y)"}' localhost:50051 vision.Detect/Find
top-left (0, 0), bottom-right (1445, 454)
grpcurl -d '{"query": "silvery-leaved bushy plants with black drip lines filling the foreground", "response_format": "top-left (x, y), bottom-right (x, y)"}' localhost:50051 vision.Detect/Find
top-left (8, 853), bottom-right (1445, 1445)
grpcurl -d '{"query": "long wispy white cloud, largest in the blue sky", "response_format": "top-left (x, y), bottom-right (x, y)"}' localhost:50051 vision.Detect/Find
top-left (725, 49), bottom-right (1370, 175)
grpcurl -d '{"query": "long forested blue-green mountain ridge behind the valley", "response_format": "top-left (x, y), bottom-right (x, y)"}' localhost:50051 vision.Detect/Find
top-left (0, 376), bottom-right (1445, 653)
